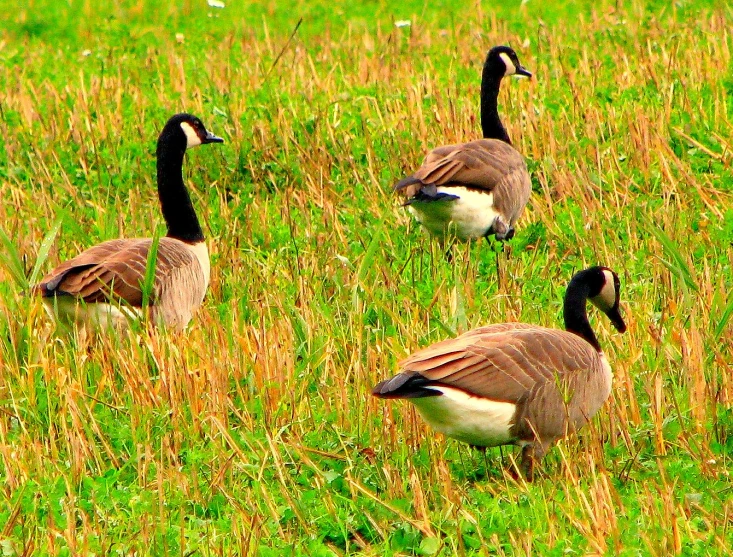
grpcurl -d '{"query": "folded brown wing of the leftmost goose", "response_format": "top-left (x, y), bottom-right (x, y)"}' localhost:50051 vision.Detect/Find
top-left (34, 238), bottom-right (199, 307)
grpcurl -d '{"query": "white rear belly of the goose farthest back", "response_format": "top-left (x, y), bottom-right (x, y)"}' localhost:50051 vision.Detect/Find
top-left (408, 186), bottom-right (499, 240)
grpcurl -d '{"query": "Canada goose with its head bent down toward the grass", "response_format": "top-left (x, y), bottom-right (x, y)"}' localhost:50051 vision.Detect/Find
top-left (372, 267), bottom-right (626, 481)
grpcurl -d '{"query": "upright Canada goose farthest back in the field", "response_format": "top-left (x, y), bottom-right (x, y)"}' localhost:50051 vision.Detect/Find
top-left (394, 46), bottom-right (532, 240)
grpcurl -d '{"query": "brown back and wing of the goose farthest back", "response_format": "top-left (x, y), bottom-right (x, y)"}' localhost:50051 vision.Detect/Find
top-left (394, 139), bottom-right (532, 222)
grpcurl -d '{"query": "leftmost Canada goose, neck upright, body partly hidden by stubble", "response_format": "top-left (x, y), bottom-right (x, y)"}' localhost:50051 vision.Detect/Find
top-left (34, 114), bottom-right (224, 330)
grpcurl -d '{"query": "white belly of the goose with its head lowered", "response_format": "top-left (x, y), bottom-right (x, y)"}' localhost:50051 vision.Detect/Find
top-left (410, 386), bottom-right (516, 447)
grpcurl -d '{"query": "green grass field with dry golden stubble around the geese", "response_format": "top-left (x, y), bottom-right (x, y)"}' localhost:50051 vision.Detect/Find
top-left (0, 0), bottom-right (733, 556)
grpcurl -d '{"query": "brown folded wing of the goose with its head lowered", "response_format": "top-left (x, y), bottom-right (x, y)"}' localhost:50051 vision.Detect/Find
top-left (374, 323), bottom-right (599, 404)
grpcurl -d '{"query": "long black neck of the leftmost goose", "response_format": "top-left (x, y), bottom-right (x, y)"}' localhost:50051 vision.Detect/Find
top-left (157, 135), bottom-right (204, 243)
